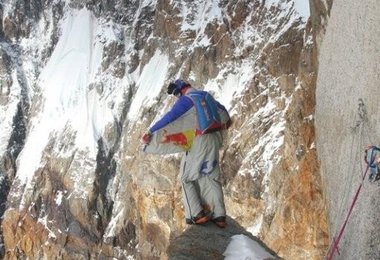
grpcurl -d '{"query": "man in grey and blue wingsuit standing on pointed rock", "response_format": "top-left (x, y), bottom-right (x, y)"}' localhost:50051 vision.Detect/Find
top-left (142, 79), bottom-right (231, 228)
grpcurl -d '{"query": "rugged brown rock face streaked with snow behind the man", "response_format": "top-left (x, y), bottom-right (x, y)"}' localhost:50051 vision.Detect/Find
top-left (0, 0), bottom-right (331, 259)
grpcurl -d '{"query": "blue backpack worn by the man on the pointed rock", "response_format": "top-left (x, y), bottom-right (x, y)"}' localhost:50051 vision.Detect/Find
top-left (186, 91), bottom-right (222, 135)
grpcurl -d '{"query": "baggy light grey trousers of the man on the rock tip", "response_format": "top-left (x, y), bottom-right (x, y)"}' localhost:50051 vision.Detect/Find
top-left (180, 134), bottom-right (226, 219)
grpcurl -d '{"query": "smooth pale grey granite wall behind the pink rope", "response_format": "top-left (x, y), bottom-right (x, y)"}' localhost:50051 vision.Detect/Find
top-left (316, 0), bottom-right (380, 259)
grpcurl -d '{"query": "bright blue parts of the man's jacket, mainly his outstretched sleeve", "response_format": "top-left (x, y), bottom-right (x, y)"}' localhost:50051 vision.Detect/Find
top-left (149, 90), bottom-right (227, 133)
